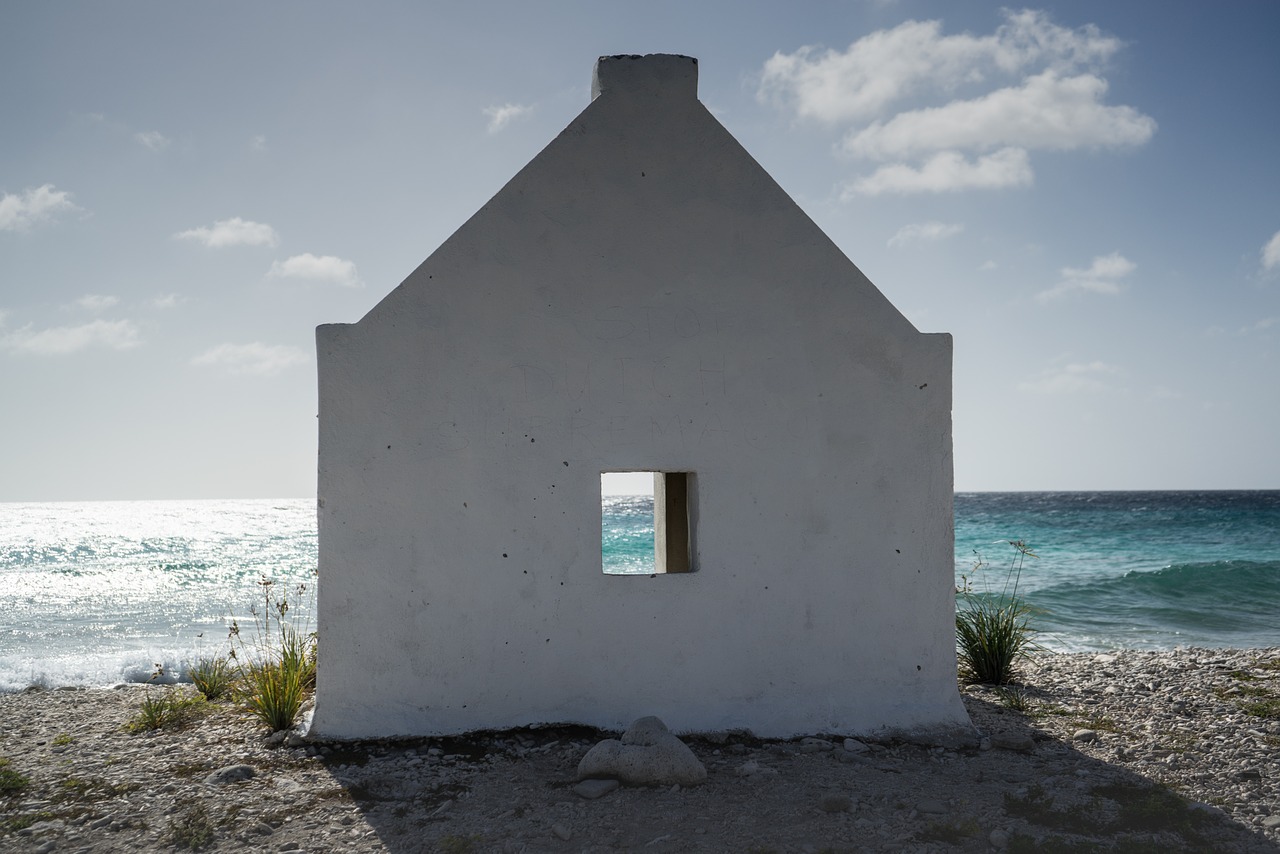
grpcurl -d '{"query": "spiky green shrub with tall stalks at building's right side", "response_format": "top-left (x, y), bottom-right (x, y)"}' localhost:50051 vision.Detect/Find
top-left (956, 540), bottom-right (1038, 685)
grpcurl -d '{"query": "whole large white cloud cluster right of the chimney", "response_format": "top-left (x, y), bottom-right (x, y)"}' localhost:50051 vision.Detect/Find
top-left (756, 10), bottom-right (1156, 200)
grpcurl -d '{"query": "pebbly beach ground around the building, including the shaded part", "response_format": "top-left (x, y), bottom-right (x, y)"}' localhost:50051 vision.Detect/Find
top-left (0, 648), bottom-right (1280, 854)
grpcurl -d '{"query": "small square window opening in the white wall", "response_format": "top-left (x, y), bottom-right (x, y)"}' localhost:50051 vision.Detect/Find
top-left (600, 471), bottom-right (692, 575)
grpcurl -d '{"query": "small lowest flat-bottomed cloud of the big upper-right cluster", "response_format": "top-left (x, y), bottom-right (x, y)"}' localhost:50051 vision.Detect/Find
top-left (841, 149), bottom-right (1036, 201)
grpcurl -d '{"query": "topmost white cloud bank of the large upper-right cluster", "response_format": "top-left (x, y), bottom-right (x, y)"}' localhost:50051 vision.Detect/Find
top-left (756, 10), bottom-right (1120, 123)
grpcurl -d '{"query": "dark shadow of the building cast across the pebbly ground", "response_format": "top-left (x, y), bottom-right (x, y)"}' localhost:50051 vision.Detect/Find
top-left (309, 694), bottom-right (1280, 854)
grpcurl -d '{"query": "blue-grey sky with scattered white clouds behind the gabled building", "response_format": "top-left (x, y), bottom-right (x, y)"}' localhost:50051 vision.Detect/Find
top-left (0, 0), bottom-right (1280, 501)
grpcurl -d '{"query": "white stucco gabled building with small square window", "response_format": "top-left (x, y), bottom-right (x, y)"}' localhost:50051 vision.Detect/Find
top-left (312, 55), bottom-right (969, 737)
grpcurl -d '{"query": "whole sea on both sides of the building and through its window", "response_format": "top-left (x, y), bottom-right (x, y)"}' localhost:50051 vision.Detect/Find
top-left (0, 492), bottom-right (1280, 691)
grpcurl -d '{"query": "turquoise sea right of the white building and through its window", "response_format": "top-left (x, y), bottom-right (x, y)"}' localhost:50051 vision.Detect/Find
top-left (602, 492), bottom-right (1280, 652)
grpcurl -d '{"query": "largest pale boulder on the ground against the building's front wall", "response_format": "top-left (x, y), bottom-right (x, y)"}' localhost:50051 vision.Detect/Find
top-left (577, 716), bottom-right (707, 786)
